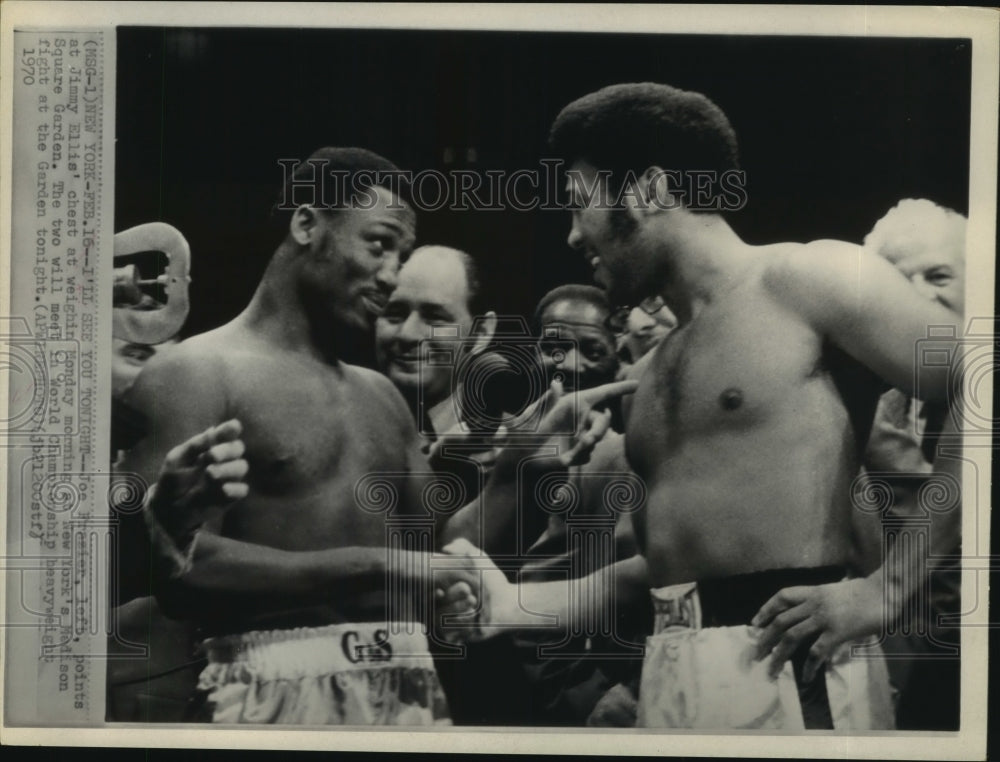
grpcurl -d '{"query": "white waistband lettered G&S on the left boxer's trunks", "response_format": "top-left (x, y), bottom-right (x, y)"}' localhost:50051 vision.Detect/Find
top-left (202, 622), bottom-right (434, 679)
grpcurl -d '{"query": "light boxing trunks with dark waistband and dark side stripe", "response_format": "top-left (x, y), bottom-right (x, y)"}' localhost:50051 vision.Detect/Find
top-left (637, 567), bottom-right (893, 730)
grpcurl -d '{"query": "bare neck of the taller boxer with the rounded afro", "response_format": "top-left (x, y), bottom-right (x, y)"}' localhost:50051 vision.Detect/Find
top-left (660, 213), bottom-right (751, 325)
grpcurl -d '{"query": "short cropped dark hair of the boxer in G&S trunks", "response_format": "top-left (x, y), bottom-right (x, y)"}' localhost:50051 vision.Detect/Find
top-left (270, 146), bottom-right (410, 230)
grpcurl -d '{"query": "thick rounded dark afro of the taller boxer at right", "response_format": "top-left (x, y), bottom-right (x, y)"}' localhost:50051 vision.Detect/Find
top-left (549, 82), bottom-right (740, 193)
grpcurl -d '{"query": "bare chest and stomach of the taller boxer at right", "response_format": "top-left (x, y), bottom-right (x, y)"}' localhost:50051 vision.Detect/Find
top-left (627, 247), bottom-right (877, 586)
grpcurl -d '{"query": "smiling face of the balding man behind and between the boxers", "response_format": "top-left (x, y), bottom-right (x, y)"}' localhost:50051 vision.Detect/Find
top-left (375, 246), bottom-right (472, 405)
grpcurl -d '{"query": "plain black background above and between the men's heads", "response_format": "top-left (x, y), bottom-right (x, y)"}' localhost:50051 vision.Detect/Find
top-left (115, 28), bottom-right (971, 335)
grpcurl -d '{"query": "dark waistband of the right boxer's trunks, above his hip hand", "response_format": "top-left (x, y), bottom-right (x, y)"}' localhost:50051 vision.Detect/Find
top-left (650, 566), bottom-right (847, 633)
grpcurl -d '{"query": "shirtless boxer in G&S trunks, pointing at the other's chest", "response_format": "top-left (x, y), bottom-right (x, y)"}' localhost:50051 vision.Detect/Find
top-left (133, 149), bottom-right (625, 724)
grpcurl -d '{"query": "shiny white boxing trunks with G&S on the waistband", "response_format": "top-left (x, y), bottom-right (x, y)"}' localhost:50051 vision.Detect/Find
top-left (198, 623), bottom-right (451, 725)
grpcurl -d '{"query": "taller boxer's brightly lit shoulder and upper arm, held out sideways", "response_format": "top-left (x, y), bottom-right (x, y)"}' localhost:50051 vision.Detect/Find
top-left (766, 241), bottom-right (962, 404)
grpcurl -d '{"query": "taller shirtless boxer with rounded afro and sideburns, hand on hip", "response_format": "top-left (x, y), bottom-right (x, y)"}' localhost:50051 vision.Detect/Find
top-left (444, 83), bottom-right (960, 729)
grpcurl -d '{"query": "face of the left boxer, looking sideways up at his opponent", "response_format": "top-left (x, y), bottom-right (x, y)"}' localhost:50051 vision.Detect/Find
top-left (300, 187), bottom-right (416, 334)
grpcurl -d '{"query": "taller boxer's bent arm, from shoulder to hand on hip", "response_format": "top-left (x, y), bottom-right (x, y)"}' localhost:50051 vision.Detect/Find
top-left (752, 242), bottom-right (962, 679)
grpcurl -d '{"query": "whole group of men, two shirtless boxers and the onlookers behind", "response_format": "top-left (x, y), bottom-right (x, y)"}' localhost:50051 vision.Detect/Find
top-left (109, 83), bottom-right (965, 730)
